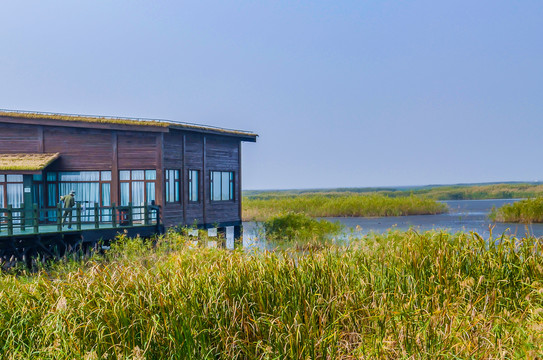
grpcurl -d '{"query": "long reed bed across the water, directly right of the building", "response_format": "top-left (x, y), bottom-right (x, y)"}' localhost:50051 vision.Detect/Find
top-left (243, 193), bottom-right (447, 221)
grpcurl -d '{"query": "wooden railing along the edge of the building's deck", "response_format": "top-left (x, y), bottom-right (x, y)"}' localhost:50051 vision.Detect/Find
top-left (0, 203), bottom-right (160, 236)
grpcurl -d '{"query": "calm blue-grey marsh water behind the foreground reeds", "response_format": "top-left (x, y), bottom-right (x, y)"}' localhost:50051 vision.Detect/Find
top-left (243, 199), bottom-right (543, 248)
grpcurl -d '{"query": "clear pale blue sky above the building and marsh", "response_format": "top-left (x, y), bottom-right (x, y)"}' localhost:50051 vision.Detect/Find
top-left (0, 0), bottom-right (543, 189)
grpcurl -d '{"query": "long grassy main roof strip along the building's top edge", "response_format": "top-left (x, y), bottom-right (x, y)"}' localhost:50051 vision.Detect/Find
top-left (0, 110), bottom-right (258, 137)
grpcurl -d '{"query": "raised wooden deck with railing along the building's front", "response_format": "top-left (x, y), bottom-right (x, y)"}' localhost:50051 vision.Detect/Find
top-left (0, 204), bottom-right (162, 265)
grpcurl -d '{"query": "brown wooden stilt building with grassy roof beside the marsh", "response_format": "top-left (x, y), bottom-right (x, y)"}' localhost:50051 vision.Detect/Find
top-left (0, 110), bottom-right (257, 262)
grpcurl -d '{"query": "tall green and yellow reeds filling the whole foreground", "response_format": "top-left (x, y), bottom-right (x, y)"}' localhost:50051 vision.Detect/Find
top-left (0, 231), bottom-right (543, 359)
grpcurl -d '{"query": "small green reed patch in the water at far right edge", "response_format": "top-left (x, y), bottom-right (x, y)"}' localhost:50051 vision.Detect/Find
top-left (489, 197), bottom-right (543, 224)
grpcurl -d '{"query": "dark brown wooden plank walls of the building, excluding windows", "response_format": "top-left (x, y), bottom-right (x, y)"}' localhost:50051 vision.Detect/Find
top-left (0, 117), bottom-right (251, 227)
